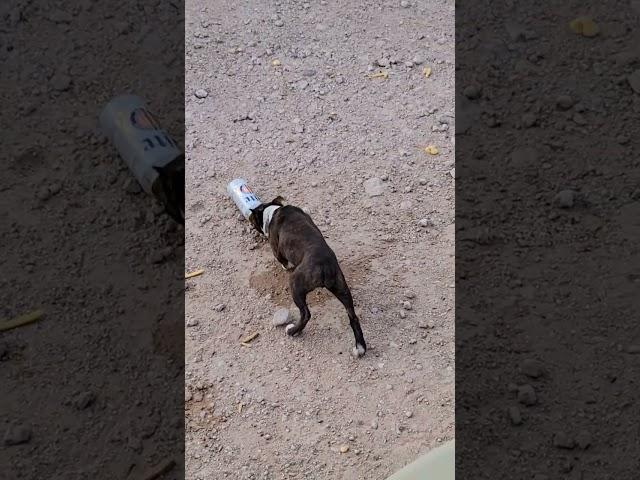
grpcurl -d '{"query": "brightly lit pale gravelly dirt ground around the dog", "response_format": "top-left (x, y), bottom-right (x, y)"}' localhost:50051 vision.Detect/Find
top-left (185, 0), bottom-right (455, 479)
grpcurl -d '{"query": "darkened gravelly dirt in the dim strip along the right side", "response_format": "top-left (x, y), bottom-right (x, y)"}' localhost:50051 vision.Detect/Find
top-left (456, 0), bottom-right (640, 480)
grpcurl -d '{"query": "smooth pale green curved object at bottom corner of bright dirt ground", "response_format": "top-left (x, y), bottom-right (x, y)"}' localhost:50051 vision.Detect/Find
top-left (387, 440), bottom-right (456, 480)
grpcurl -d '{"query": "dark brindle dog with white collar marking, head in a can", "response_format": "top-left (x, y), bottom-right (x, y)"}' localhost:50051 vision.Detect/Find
top-left (249, 197), bottom-right (367, 358)
